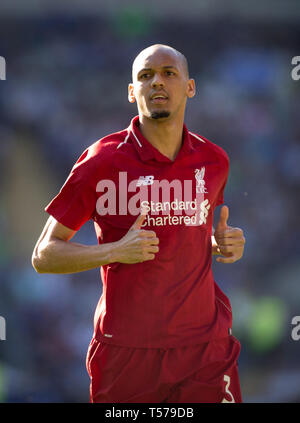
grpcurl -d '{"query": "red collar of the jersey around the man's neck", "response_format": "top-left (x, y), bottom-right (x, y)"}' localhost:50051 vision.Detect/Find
top-left (128, 116), bottom-right (194, 163)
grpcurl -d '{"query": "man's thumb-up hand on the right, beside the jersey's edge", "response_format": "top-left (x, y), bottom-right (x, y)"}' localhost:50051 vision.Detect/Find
top-left (214, 206), bottom-right (246, 263)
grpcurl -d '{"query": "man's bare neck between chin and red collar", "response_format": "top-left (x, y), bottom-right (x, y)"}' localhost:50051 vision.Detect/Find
top-left (139, 115), bottom-right (183, 161)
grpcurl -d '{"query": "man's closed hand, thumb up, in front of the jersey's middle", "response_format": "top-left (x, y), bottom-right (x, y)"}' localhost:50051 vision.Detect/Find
top-left (112, 214), bottom-right (159, 264)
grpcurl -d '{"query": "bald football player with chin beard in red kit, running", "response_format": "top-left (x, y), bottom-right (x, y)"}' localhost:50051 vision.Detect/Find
top-left (32, 44), bottom-right (245, 403)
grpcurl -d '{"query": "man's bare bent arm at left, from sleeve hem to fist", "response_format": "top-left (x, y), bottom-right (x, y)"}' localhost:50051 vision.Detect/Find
top-left (32, 215), bottom-right (159, 273)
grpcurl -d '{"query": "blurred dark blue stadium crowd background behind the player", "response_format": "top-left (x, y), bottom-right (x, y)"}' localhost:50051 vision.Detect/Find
top-left (0, 0), bottom-right (300, 402)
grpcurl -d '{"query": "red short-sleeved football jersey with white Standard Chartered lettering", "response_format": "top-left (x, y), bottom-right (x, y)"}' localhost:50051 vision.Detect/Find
top-left (45, 116), bottom-right (232, 348)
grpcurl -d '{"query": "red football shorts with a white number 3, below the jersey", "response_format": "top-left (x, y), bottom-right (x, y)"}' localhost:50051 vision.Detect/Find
top-left (86, 335), bottom-right (242, 403)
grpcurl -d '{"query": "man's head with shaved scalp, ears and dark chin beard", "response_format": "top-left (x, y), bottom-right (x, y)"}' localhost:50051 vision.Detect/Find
top-left (128, 47), bottom-right (195, 120)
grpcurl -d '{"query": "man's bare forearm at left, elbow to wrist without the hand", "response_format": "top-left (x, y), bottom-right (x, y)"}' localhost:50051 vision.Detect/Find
top-left (32, 239), bottom-right (115, 273)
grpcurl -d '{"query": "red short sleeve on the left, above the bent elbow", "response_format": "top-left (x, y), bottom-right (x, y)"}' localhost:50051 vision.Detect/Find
top-left (45, 149), bottom-right (96, 231)
